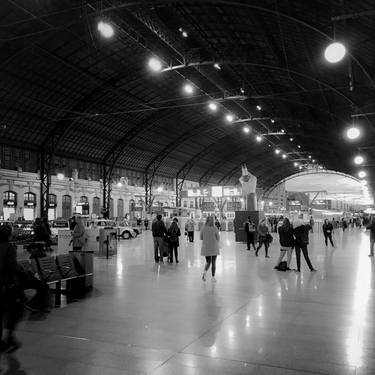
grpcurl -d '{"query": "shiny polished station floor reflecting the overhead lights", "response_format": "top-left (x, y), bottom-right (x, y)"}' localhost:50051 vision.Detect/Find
top-left (0, 230), bottom-right (375, 375)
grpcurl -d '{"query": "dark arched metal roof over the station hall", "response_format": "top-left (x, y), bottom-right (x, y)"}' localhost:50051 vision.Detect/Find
top-left (0, 0), bottom-right (375, 188)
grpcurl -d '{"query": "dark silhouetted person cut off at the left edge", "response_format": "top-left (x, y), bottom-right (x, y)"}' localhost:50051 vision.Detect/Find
top-left (0, 225), bottom-right (24, 353)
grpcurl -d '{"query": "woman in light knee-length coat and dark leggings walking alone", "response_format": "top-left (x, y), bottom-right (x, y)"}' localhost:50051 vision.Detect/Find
top-left (200, 216), bottom-right (220, 282)
